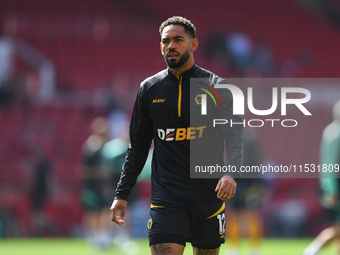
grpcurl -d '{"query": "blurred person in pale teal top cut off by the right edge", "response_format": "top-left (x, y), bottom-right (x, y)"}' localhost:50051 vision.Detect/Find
top-left (302, 100), bottom-right (340, 255)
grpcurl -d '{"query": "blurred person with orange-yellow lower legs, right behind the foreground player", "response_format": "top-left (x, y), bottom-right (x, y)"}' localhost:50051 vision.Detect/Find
top-left (226, 128), bottom-right (264, 255)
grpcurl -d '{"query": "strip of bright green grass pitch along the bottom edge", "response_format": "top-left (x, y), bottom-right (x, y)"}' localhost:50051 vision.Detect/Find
top-left (0, 238), bottom-right (335, 255)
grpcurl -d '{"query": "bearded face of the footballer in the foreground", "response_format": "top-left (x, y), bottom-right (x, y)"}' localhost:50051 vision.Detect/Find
top-left (161, 25), bottom-right (193, 69)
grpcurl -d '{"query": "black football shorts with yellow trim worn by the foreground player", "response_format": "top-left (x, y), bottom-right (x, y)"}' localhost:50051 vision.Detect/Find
top-left (148, 200), bottom-right (225, 249)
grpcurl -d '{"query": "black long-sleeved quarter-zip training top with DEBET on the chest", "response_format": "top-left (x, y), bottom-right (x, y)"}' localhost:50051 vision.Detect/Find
top-left (115, 65), bottom-right (243, 201)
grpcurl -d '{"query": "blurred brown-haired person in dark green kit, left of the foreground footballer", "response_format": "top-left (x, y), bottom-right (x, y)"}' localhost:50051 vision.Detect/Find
top-left (81, 117), bottom-right (111, 250)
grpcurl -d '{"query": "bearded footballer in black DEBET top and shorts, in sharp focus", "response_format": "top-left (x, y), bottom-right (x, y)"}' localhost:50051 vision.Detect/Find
top-left (110, 16), bottom-right (243, 255)
